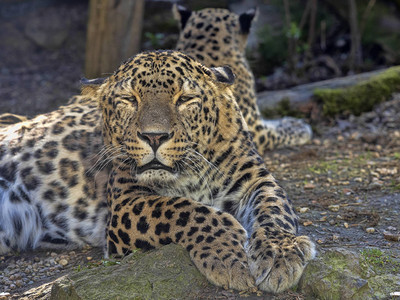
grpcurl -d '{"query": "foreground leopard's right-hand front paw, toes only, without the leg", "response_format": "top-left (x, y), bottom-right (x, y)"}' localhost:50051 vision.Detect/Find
top-left (247, 228), bottom-right (315, 293)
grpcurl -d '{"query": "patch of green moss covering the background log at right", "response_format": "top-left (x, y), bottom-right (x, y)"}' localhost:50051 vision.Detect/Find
top-left (314, 66), bottom-right (400, 116)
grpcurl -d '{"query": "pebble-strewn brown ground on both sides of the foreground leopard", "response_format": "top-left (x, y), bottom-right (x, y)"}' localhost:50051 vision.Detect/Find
top-left (0, 94), bottom-right (400, 299)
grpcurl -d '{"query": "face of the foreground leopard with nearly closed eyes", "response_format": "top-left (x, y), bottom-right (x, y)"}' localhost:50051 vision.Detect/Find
top-left (100, 51), bottom-right (241, 185)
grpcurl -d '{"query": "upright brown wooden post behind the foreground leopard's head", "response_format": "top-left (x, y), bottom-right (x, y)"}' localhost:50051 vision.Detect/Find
top-left (85, 0), bottom-right (144, 78)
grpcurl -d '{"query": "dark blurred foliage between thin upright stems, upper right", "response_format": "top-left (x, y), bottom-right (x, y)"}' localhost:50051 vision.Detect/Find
top-left (255, 0), bottom-right (400, 76)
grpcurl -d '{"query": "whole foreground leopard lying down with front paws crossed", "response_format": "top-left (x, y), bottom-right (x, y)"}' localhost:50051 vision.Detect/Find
top-left (0, 51), bottom-right (315, 292)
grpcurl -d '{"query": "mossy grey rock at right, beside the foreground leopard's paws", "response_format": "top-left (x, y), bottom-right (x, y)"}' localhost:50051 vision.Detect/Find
top-left (298, 248), bottom-right (400, 300)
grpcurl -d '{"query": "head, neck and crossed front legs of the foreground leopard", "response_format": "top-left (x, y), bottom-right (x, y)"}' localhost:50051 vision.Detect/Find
top-left (96, 50), bottom-right (315, 293)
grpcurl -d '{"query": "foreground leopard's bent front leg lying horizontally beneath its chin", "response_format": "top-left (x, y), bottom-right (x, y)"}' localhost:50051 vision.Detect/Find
top-left (107, 180), bottom-right (254, 290)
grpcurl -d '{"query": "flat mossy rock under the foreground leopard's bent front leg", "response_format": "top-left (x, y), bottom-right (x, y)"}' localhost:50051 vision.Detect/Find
top-left (50, 244), bottom-right (210, 300)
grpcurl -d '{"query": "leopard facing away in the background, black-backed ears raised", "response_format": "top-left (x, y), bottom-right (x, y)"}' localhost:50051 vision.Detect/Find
top-left (0, 4), bottom-right (313, 155)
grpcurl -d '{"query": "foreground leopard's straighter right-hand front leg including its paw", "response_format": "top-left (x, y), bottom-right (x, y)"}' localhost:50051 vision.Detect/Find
top-left (236, 174), bottom-right (315, 293)
